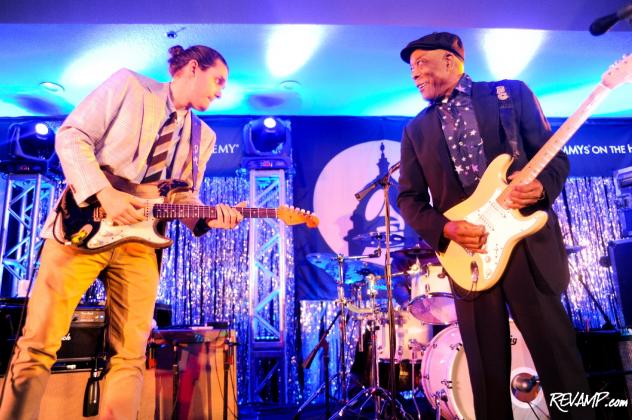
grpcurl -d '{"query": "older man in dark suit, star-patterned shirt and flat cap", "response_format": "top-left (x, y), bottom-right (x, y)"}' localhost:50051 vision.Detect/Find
top-left (398, 32), bottom-right (594, 420)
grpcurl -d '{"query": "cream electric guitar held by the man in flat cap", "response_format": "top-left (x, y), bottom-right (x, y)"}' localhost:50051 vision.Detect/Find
top-left (437, 55), bottom-right (632, 291)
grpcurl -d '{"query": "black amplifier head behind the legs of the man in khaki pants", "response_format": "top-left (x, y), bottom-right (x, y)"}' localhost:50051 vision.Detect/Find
top-left (0, 299), bottom-right (106, 374)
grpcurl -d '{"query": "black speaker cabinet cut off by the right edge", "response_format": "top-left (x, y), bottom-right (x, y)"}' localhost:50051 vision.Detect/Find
top-left (608, 239), bottom-right (632, 327)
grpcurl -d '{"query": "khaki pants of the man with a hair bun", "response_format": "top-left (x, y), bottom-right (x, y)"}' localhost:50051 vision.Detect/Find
top-left (0, 239), bottom-right (158, 420)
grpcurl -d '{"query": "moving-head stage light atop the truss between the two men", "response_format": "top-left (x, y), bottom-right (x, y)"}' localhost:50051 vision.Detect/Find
top-left (242, 117), bottom-right (292, 169)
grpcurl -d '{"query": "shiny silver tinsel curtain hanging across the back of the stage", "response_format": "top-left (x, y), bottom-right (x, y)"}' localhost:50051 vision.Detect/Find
top-left (61, 173), bottom-right (623, 403)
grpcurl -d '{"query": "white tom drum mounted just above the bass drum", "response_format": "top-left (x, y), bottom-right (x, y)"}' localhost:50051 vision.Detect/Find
top-left (408, 264), bottom-right (456, 325)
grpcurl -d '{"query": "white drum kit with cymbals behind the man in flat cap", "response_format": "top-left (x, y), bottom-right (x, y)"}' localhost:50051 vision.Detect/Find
top-left (307, 243), bottom-right (548, 419)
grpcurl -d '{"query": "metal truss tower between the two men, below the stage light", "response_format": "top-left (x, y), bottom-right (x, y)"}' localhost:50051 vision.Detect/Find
top-left (248, 170), bottom-right (292, 405)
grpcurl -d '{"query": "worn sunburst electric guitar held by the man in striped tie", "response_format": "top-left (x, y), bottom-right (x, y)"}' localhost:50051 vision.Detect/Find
top-left (54, 180), bottom-right (319, 252)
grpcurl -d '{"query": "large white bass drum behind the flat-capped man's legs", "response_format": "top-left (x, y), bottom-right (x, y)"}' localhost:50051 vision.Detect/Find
top-left (421, 320), bottom-right (549, 420)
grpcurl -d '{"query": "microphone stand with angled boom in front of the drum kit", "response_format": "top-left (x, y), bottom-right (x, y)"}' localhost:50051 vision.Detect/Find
top-left (332, 162), bottom-right (407, 418)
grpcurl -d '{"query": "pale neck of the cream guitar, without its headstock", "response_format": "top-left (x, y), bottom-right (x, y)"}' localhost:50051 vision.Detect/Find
top-left (510, 83), bottom-right (611, 185)
